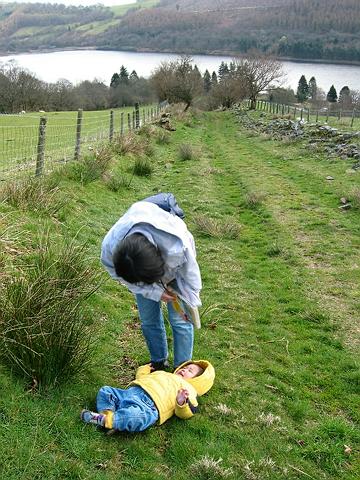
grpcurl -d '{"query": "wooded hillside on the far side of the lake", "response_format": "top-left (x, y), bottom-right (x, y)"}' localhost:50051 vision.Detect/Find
top-left (0, 0), bottom-right (360, 62)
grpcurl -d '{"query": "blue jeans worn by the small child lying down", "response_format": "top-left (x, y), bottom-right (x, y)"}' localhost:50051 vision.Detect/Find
top-left (96, 386), bottom-right (159, 432)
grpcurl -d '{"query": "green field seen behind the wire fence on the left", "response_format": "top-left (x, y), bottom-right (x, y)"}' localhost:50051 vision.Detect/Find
top-left (0, 106), bottom-right (156, 177)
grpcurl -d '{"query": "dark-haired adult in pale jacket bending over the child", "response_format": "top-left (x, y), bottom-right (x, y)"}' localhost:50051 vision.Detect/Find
top-left (101, 194), bottom-right (201, 370)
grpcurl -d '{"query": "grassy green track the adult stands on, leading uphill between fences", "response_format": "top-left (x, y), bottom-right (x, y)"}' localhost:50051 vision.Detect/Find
top-left (0, 112), bottom-right (360, 480)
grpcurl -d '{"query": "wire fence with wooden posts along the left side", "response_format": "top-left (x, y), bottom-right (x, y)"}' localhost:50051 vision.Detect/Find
top-left (0, 104), bottom-right (160, 181)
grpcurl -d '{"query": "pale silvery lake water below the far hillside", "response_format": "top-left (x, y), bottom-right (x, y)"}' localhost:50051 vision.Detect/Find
top-left (0, 50), bottom-right (360, 93)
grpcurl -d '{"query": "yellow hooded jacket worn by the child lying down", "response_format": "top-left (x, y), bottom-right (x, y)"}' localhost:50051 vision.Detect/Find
top-left (130, 360), bottom-right (215, 424)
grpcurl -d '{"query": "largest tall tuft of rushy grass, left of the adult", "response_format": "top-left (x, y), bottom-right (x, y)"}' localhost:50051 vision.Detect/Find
top-left (0, 234), bottom-right (100, 387)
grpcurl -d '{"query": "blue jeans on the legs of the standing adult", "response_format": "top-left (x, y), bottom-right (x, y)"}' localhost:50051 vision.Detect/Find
top-left (136, 294), bottom-right (194, 368)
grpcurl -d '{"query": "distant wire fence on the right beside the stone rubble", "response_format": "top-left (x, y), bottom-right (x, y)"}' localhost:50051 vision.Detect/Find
top-left (247, 100), bottom-right (360, 129)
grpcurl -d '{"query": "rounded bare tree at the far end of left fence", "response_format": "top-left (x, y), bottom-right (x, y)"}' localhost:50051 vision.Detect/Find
top-left (151, 55), bottom-right (202, 110)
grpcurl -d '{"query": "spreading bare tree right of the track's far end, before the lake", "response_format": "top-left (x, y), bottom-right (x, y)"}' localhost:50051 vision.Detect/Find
top-left (234, 52), bottom-right (285, 109)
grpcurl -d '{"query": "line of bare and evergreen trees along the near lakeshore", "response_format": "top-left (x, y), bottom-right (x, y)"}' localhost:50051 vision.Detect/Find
top-left (0, 52), bottom-right (360, 113)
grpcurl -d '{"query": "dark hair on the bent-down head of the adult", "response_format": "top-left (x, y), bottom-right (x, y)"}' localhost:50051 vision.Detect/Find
top-left (113, 233), bottom-right (164, 284)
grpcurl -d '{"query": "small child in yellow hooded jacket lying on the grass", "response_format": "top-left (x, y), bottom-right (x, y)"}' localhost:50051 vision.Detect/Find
top-left (81, 360), bottom-right (215, 432)
